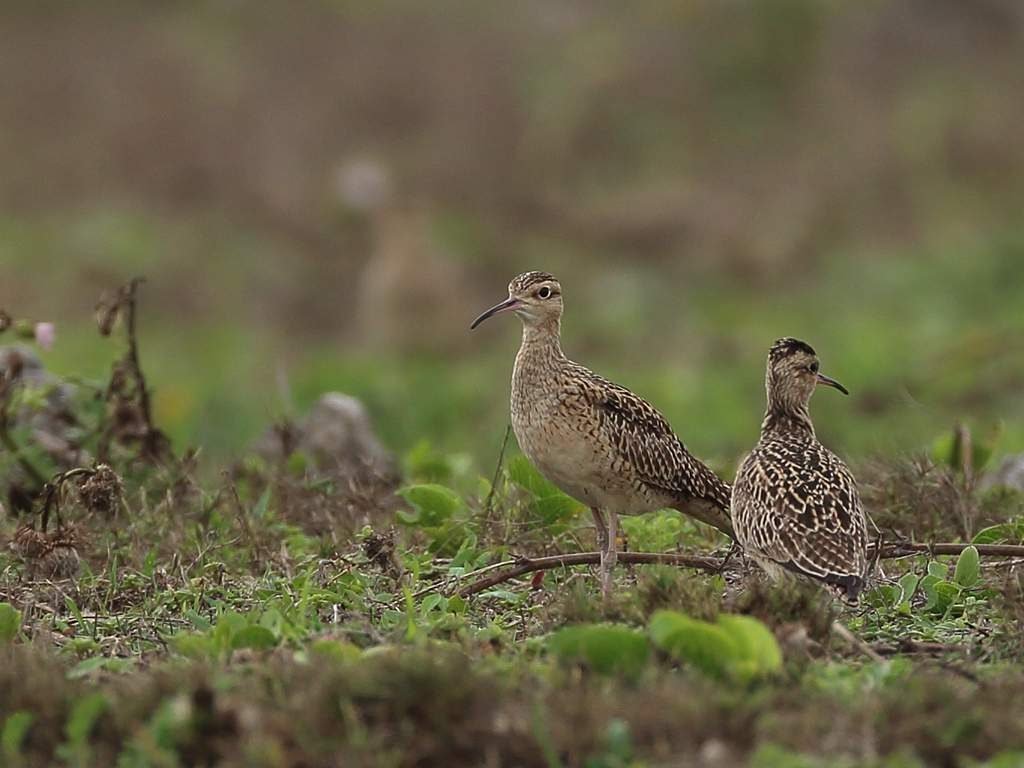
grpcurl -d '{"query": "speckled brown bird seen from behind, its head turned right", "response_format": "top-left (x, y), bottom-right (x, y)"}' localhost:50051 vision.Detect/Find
top-left (732, 338), bottom-right (867, 600)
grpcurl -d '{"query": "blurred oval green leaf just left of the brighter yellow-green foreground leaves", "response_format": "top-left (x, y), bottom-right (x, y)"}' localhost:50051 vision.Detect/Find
top-left (548, 624), bottom-right (650, 677)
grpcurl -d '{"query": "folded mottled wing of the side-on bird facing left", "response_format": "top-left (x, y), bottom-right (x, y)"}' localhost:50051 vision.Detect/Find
top-left (584, 364), bottom-right (730, 511)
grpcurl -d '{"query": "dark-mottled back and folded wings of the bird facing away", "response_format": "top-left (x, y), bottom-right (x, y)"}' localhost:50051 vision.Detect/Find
top-left (732, 437), bottom-right (867, 597)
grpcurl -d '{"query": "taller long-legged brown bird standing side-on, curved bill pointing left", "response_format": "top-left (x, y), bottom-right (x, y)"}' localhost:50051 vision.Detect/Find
top-left (472, 271), bottom-right (732, 594)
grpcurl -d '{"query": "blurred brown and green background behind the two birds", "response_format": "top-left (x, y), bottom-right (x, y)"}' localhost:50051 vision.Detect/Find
top-left (0, 0), bottom-right (1024, 470)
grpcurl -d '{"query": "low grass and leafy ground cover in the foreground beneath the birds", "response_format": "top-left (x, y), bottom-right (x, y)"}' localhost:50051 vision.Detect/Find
top-left (0, 421), bottom-right (1024, 766)
